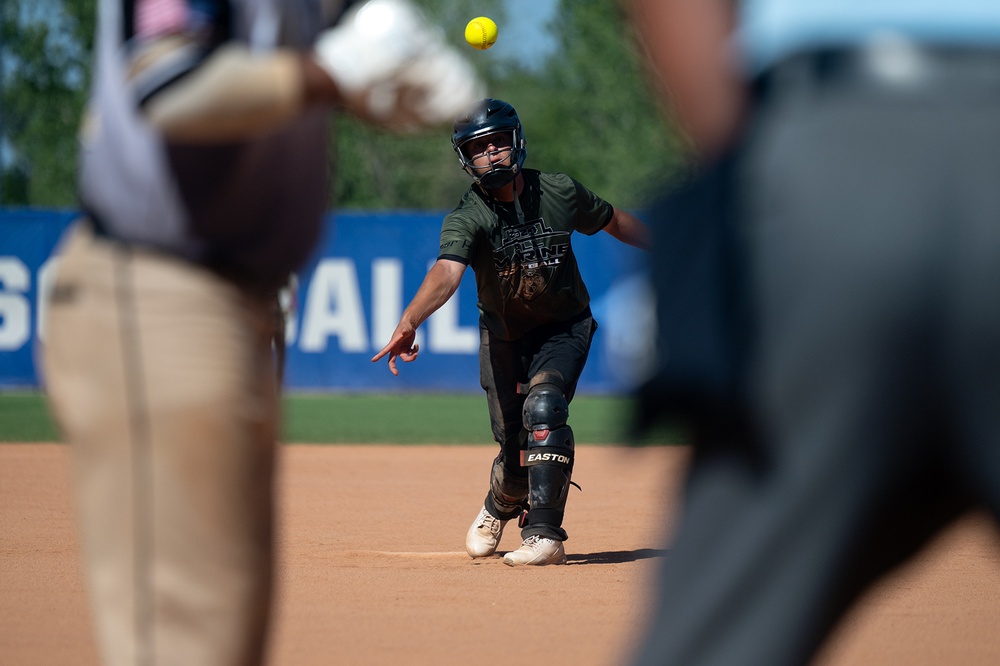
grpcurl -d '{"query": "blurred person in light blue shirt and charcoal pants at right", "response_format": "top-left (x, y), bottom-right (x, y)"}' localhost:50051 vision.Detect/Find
top-left (630, 0), bottom-right (1000, 666)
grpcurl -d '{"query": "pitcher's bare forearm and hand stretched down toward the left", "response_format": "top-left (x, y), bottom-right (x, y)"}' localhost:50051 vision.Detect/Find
top-left (372, 259), bottom-right (465, 377)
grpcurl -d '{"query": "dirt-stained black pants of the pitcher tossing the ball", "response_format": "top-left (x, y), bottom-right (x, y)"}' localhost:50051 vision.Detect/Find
top-left (479, 308), bottom-right (597, 540)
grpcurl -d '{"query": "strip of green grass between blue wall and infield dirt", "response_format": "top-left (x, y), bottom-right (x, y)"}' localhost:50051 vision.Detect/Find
top-left (0, 392), bottom-right (672, 444)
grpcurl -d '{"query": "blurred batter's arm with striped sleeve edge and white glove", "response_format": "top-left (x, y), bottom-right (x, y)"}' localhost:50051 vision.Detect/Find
top-left (138, 0), bottom-right (483, 143)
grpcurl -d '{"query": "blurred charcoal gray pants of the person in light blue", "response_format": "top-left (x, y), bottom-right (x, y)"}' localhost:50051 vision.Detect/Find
top-left (637, 46), bottom-right (1000, 666)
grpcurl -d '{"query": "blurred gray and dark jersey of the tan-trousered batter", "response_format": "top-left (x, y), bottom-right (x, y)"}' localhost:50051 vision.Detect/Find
top-left (79, 0), bottom-right (329, 285)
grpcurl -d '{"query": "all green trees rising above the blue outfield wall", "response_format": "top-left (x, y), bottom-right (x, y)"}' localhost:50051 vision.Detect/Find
top-left (0, 0), bottom-right (681, 210)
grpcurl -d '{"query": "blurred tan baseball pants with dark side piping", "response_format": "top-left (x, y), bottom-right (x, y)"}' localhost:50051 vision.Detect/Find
top-left (42, 222), bottom-right (278, 666)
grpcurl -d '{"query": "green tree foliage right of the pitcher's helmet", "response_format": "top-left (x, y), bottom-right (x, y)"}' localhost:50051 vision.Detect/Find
top-left (488, 0), bottom-right (681, 207)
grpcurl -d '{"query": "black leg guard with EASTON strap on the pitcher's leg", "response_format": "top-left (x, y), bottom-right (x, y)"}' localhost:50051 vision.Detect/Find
top-left (521, 383), bottom-right (574, 540)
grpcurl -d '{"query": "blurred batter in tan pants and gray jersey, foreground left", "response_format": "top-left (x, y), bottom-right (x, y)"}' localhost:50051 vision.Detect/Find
top-left (43, 0), bottom-right (481, 666)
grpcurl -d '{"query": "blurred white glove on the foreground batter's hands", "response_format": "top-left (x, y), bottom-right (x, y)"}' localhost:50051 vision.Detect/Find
top-left (315, 0), bottom-right (485, 132)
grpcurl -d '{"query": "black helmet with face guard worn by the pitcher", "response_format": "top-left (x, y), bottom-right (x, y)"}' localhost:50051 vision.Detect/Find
top-left (451, 99), bottom-right (528, 190)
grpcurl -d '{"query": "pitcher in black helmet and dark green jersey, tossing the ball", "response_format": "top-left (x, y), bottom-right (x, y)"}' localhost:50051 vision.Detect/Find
top-left (372, 99), bottom-right (647, 566)
